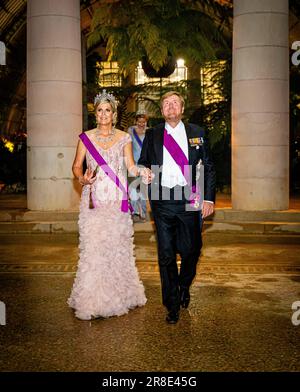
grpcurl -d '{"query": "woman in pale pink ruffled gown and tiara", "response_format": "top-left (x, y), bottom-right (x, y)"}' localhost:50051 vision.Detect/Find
top-left (68, 90), bottom-right (149, 320)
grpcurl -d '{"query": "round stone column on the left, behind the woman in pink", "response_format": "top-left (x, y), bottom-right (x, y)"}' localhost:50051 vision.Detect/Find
top-left (27, 0), bottom-right (82, 210)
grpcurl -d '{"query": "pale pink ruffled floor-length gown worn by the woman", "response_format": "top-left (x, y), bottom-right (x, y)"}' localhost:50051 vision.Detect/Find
top-left (68, 134), bottom-right (147, 320)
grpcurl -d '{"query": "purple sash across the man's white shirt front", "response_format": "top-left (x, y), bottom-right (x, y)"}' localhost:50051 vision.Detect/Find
top-left (164, 129), bottom-right (200, 208)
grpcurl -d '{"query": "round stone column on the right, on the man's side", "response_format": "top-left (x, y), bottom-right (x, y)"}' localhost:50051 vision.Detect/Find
top-left (232, 0), bottom-right (289, 210)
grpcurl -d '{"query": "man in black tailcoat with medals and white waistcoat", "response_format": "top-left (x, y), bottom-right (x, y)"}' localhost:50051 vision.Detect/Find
top-left (138, 91), bottom-right (216, 324)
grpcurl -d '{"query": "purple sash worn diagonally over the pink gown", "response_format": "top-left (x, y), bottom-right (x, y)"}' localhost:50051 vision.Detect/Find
top-left (79, 132), bottom-right (131, 212)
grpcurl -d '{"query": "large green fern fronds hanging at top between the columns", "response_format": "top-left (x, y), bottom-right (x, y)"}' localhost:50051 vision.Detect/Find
top-left (88, 0), bottom-right (231, 74)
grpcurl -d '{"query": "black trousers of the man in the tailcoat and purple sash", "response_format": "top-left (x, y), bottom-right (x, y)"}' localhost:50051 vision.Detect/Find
top-left (151, 200), bottom-right (202, 311)
